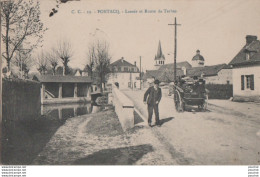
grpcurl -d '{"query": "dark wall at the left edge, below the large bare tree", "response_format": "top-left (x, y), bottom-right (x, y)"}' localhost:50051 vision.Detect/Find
top-left (2, 79), bottom-right (41, 120)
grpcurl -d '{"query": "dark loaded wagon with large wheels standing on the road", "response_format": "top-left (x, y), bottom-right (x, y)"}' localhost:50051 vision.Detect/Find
top-left (174, 78), bottom-right (208, 112)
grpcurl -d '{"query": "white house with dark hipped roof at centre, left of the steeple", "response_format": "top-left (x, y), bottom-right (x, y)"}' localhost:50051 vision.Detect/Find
top-left (107, 57), bottom-right (140, 89)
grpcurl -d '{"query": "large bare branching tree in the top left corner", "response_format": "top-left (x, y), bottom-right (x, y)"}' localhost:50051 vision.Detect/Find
top-left (1, 0), bottom-right (47, 71)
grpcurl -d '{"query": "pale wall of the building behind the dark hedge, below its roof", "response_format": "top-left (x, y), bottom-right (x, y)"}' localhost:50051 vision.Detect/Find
top-left (205, 69), bottom-right (233, 84)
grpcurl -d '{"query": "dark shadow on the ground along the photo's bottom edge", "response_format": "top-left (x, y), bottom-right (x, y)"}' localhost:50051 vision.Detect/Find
top-left (73, 144), bottom-right (153, 165)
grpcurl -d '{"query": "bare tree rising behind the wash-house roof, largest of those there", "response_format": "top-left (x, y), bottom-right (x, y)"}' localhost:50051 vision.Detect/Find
top-left (55, 40), bottom-right (73, 75)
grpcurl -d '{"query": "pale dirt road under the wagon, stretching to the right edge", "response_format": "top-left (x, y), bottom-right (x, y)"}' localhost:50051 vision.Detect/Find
top-left (124, 91), bottom-right (260, 165)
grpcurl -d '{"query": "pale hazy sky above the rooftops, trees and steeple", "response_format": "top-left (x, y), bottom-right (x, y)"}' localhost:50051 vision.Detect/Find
top-left (35, 0), bottom-right (260, 71)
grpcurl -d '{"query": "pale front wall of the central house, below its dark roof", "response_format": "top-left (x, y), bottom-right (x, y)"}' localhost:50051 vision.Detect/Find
top-left (107, 73), bottom-right (140, 89)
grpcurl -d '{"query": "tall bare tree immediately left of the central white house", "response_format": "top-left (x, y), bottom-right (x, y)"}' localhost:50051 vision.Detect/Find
top-left (93, 40), bottom-right (111, 92)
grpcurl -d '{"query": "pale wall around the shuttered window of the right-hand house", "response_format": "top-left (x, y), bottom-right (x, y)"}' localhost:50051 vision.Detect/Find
top-left (233, 66), bottom-right (260, 101)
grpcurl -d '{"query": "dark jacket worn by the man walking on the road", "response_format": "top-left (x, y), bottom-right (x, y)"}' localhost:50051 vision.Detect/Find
top-left (144, 86), bottom-right (162, 105)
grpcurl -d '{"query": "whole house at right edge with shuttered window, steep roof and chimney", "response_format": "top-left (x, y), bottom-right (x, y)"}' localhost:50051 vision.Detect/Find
top-left (229, 35), bottom-right (260, 101)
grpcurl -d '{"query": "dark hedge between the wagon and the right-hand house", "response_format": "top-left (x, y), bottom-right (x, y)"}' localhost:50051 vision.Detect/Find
top-left (206, 84), bottom-right (233, 99)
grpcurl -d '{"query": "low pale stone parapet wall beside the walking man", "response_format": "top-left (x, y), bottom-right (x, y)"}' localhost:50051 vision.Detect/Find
top-left (112, 86), bottom-right (134, 131)
